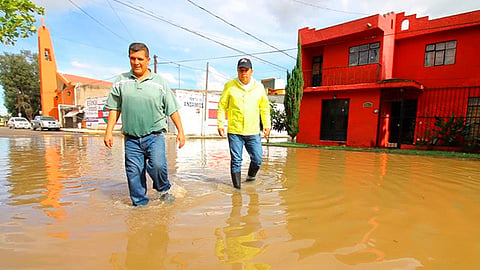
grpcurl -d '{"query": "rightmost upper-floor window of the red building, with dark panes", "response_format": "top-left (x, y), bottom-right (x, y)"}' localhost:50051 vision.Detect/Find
top-left (425, 40), bottom-right (457, 67)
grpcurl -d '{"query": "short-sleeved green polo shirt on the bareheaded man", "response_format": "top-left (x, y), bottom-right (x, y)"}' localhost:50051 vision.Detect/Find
top-left (105, 71), bottom-right (180, 137)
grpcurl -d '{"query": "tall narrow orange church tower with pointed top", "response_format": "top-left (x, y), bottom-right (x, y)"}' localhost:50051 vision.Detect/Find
top-left (37, 18), bottom-right (58, 120)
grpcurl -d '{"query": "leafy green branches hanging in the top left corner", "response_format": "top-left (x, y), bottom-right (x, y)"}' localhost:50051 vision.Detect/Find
top-left (0, 0), bottom-right (45, 45)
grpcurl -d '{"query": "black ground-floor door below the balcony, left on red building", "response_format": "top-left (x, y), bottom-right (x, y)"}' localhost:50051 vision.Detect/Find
top-left (320, 99), bottom-right (350, 142)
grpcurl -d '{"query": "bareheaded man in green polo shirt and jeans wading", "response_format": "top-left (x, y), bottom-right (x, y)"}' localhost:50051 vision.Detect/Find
top-left (104, 43), bottom-right (185, 206)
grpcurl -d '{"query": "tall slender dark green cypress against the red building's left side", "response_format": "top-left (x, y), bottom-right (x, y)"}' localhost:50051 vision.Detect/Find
top-left (283, 37), bottom-right (303, 141)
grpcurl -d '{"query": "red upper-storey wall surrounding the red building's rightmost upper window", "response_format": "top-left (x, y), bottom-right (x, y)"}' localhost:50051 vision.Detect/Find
top-left (393, 27), bottom-right (480, 88)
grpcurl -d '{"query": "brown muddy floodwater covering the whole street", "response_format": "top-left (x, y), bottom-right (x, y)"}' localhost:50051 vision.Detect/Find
top-left (0, 135), bottom-right (480, 270)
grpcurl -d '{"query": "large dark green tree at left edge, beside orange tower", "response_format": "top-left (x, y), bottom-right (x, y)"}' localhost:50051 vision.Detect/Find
top-left (0, 51), bottom-right (42, 119)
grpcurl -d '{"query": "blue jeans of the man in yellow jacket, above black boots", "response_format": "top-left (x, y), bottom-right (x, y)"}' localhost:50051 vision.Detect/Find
top-left (228, 133), bottom-right (263, 173)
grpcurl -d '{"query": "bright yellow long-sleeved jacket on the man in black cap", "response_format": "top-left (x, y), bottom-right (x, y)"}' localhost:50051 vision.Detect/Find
top-left (217, 78), bottom-right (272, 136)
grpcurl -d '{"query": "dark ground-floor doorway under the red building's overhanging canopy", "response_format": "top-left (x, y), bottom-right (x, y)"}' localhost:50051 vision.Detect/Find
top-left (388, 99), bottom-right (417, 144)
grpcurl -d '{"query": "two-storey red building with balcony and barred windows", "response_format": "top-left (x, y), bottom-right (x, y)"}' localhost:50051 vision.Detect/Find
top-left (297, 11), bottom-right (480, 147)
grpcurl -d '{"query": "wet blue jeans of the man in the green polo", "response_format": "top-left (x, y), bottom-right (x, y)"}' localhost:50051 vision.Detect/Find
top-left (125, 133), bottom-right (171, 206)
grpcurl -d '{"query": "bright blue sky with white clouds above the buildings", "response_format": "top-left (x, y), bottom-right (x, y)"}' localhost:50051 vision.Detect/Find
top-left (0, 0), bottom-right (480, 114)
